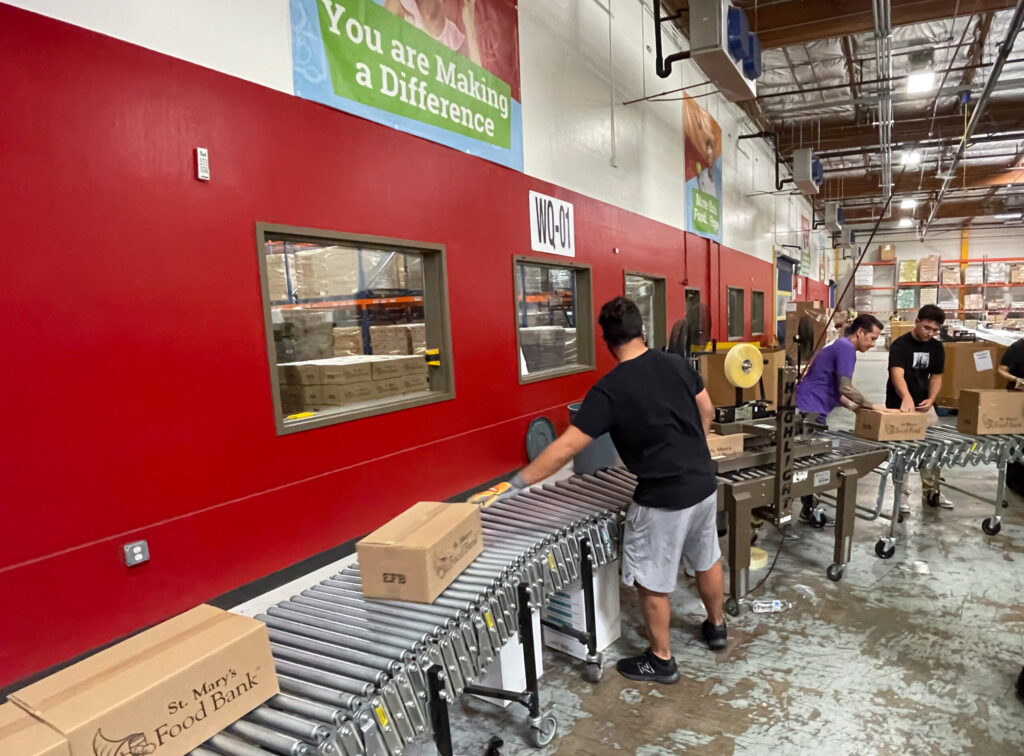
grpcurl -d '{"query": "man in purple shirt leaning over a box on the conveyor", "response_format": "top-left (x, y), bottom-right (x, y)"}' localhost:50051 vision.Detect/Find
top-left (796, 313), bottom-right (885, 527)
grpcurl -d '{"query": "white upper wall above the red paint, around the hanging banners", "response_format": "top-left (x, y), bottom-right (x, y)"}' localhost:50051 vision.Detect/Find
top-left (9, 0), bottom-right (827, 268)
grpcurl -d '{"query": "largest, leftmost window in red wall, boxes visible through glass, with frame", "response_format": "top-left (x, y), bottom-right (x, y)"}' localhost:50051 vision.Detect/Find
top-left (257, 224), bottom-right (454, 433)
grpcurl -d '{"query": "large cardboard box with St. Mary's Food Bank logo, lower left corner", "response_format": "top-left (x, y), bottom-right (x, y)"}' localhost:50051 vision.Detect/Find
top-left (7, 604), bottom-right (278, 756)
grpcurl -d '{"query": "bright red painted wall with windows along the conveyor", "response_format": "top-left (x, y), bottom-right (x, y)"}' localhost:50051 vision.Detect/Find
top-left (0, 5), bottom-right (772, 685)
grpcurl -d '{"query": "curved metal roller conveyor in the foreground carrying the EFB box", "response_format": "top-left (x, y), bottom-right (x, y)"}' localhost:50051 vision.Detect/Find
top-left (185, 469), bottom-right (635, 756)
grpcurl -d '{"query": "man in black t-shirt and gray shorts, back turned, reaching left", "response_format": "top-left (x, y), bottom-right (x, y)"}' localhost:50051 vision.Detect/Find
top-left (483, 297), bottom-right (727, 683)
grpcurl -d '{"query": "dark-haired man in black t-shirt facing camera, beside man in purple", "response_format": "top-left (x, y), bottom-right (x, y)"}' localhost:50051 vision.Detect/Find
top-left (886, 304), bottom-right (953, 513)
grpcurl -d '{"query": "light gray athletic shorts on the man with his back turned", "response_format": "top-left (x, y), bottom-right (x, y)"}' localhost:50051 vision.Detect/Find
top-left (623, 492), bottom-right (722, 593)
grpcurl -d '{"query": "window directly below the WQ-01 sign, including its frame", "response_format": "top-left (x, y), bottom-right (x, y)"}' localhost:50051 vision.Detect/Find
top-left (514, 257), bottom-right (594, 383)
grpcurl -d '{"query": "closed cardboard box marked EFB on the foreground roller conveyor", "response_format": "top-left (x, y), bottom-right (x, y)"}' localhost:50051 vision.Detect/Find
top-left (355, 501), bottom-right (483, 603)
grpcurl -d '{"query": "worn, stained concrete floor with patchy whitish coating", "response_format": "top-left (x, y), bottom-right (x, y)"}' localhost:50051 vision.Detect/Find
top-left (432, 351), bottom-right (1024, 756)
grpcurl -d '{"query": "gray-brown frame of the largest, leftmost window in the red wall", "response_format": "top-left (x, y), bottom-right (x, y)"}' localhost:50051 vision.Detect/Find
top-left (256, 222), bottom-right (456, 436)
